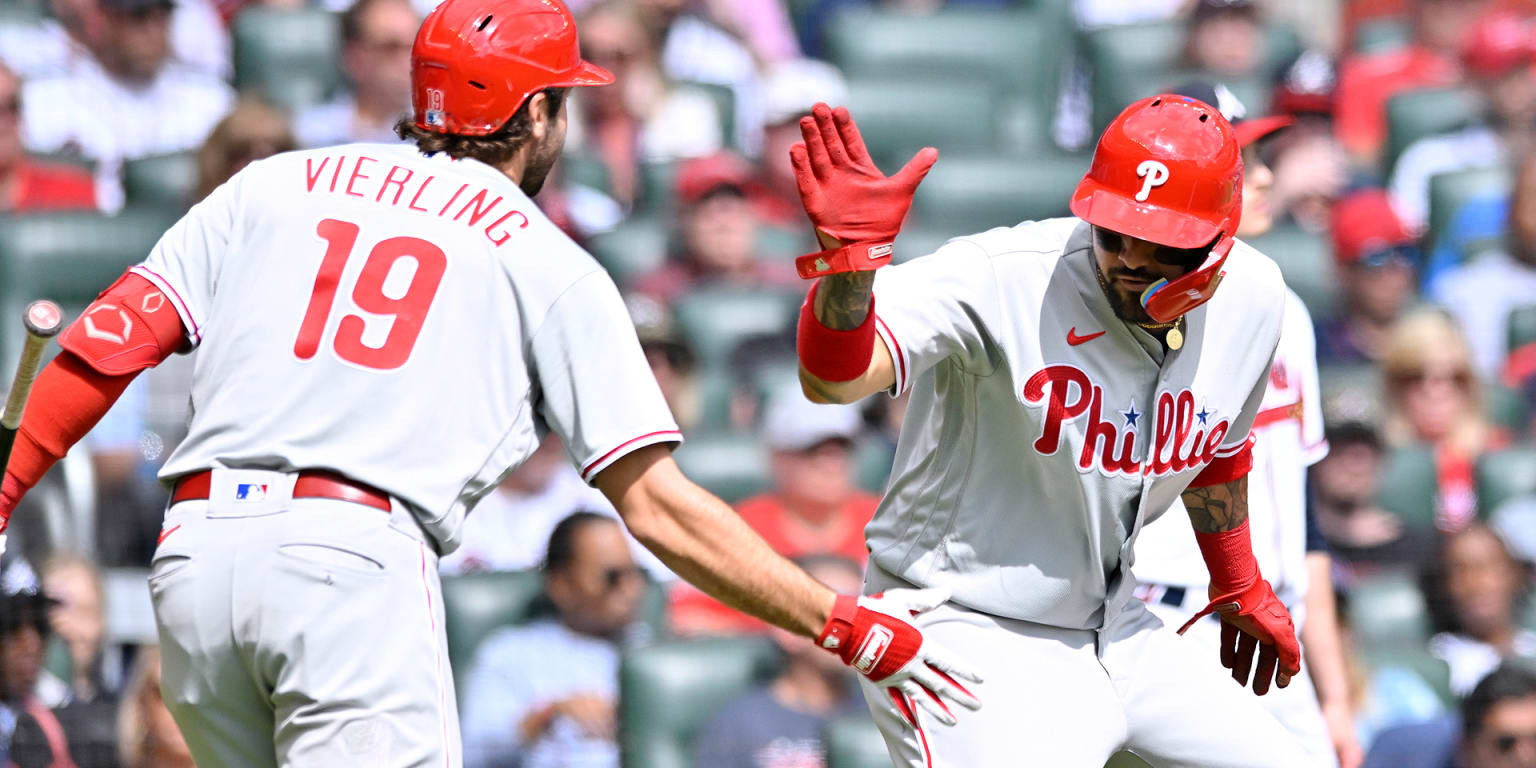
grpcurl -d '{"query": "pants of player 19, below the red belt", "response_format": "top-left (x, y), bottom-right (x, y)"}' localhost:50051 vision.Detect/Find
top-left (149, 470), bottom-right (462, 768)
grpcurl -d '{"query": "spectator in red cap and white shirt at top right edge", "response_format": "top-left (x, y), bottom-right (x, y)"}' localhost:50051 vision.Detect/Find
top-left (1392, 11), bottom-right (1536, 232)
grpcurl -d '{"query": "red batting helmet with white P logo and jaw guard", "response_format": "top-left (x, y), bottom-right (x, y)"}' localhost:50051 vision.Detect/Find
top-left (1071, 94), bottom-right (1243, 323)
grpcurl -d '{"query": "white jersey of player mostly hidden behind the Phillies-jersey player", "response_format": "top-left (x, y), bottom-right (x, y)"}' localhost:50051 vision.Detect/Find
top-left (1135, 290), bottom-right (1329, 617)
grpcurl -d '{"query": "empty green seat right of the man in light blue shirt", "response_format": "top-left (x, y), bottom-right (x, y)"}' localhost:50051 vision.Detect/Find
top-left (619, 637), bottom-right (779, 768)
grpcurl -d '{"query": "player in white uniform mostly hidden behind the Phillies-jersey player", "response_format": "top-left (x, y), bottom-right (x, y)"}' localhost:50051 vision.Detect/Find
top-left (1135, 83), bottom-right (1364, 768)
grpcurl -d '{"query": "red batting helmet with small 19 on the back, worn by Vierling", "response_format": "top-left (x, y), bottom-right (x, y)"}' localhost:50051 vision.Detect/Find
top-left (410, 0), bottom-right (613, 137)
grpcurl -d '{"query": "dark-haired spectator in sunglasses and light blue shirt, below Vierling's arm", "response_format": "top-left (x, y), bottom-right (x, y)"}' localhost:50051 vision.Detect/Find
top-left (464, 511), bottom-right (645, 768)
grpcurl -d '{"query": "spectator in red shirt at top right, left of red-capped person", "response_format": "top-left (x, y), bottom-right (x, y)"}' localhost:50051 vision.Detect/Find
top-left (1336, 0), bottom-right (1488, 166)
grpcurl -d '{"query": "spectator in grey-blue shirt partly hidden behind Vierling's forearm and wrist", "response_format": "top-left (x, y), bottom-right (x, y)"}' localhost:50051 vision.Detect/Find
top-left (694, 554), bottom-right (868, 768)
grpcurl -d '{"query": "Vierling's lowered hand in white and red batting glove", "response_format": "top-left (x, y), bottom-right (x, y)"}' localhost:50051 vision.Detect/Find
top-left (816, 588), bottom-right (982, 725)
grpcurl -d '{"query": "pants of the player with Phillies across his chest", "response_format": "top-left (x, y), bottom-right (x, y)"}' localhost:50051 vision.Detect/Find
top-left (860, 565), bottom-right (1316, 768)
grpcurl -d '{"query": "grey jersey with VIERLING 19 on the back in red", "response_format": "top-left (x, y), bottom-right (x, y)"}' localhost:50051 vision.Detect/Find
top-left (134, 144), bottom-right (680, 551)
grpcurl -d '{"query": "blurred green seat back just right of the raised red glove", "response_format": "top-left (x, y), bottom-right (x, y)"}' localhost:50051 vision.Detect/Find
top-left (848, 77), bottom-right (998, 174)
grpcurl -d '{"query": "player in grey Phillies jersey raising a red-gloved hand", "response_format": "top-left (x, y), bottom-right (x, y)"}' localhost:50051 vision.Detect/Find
top-left (791, 95), bottom-right (1309, 768)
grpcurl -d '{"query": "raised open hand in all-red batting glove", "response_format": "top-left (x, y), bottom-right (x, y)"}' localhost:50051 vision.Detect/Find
top-left (790, 104), bottom-right (938, 244)
